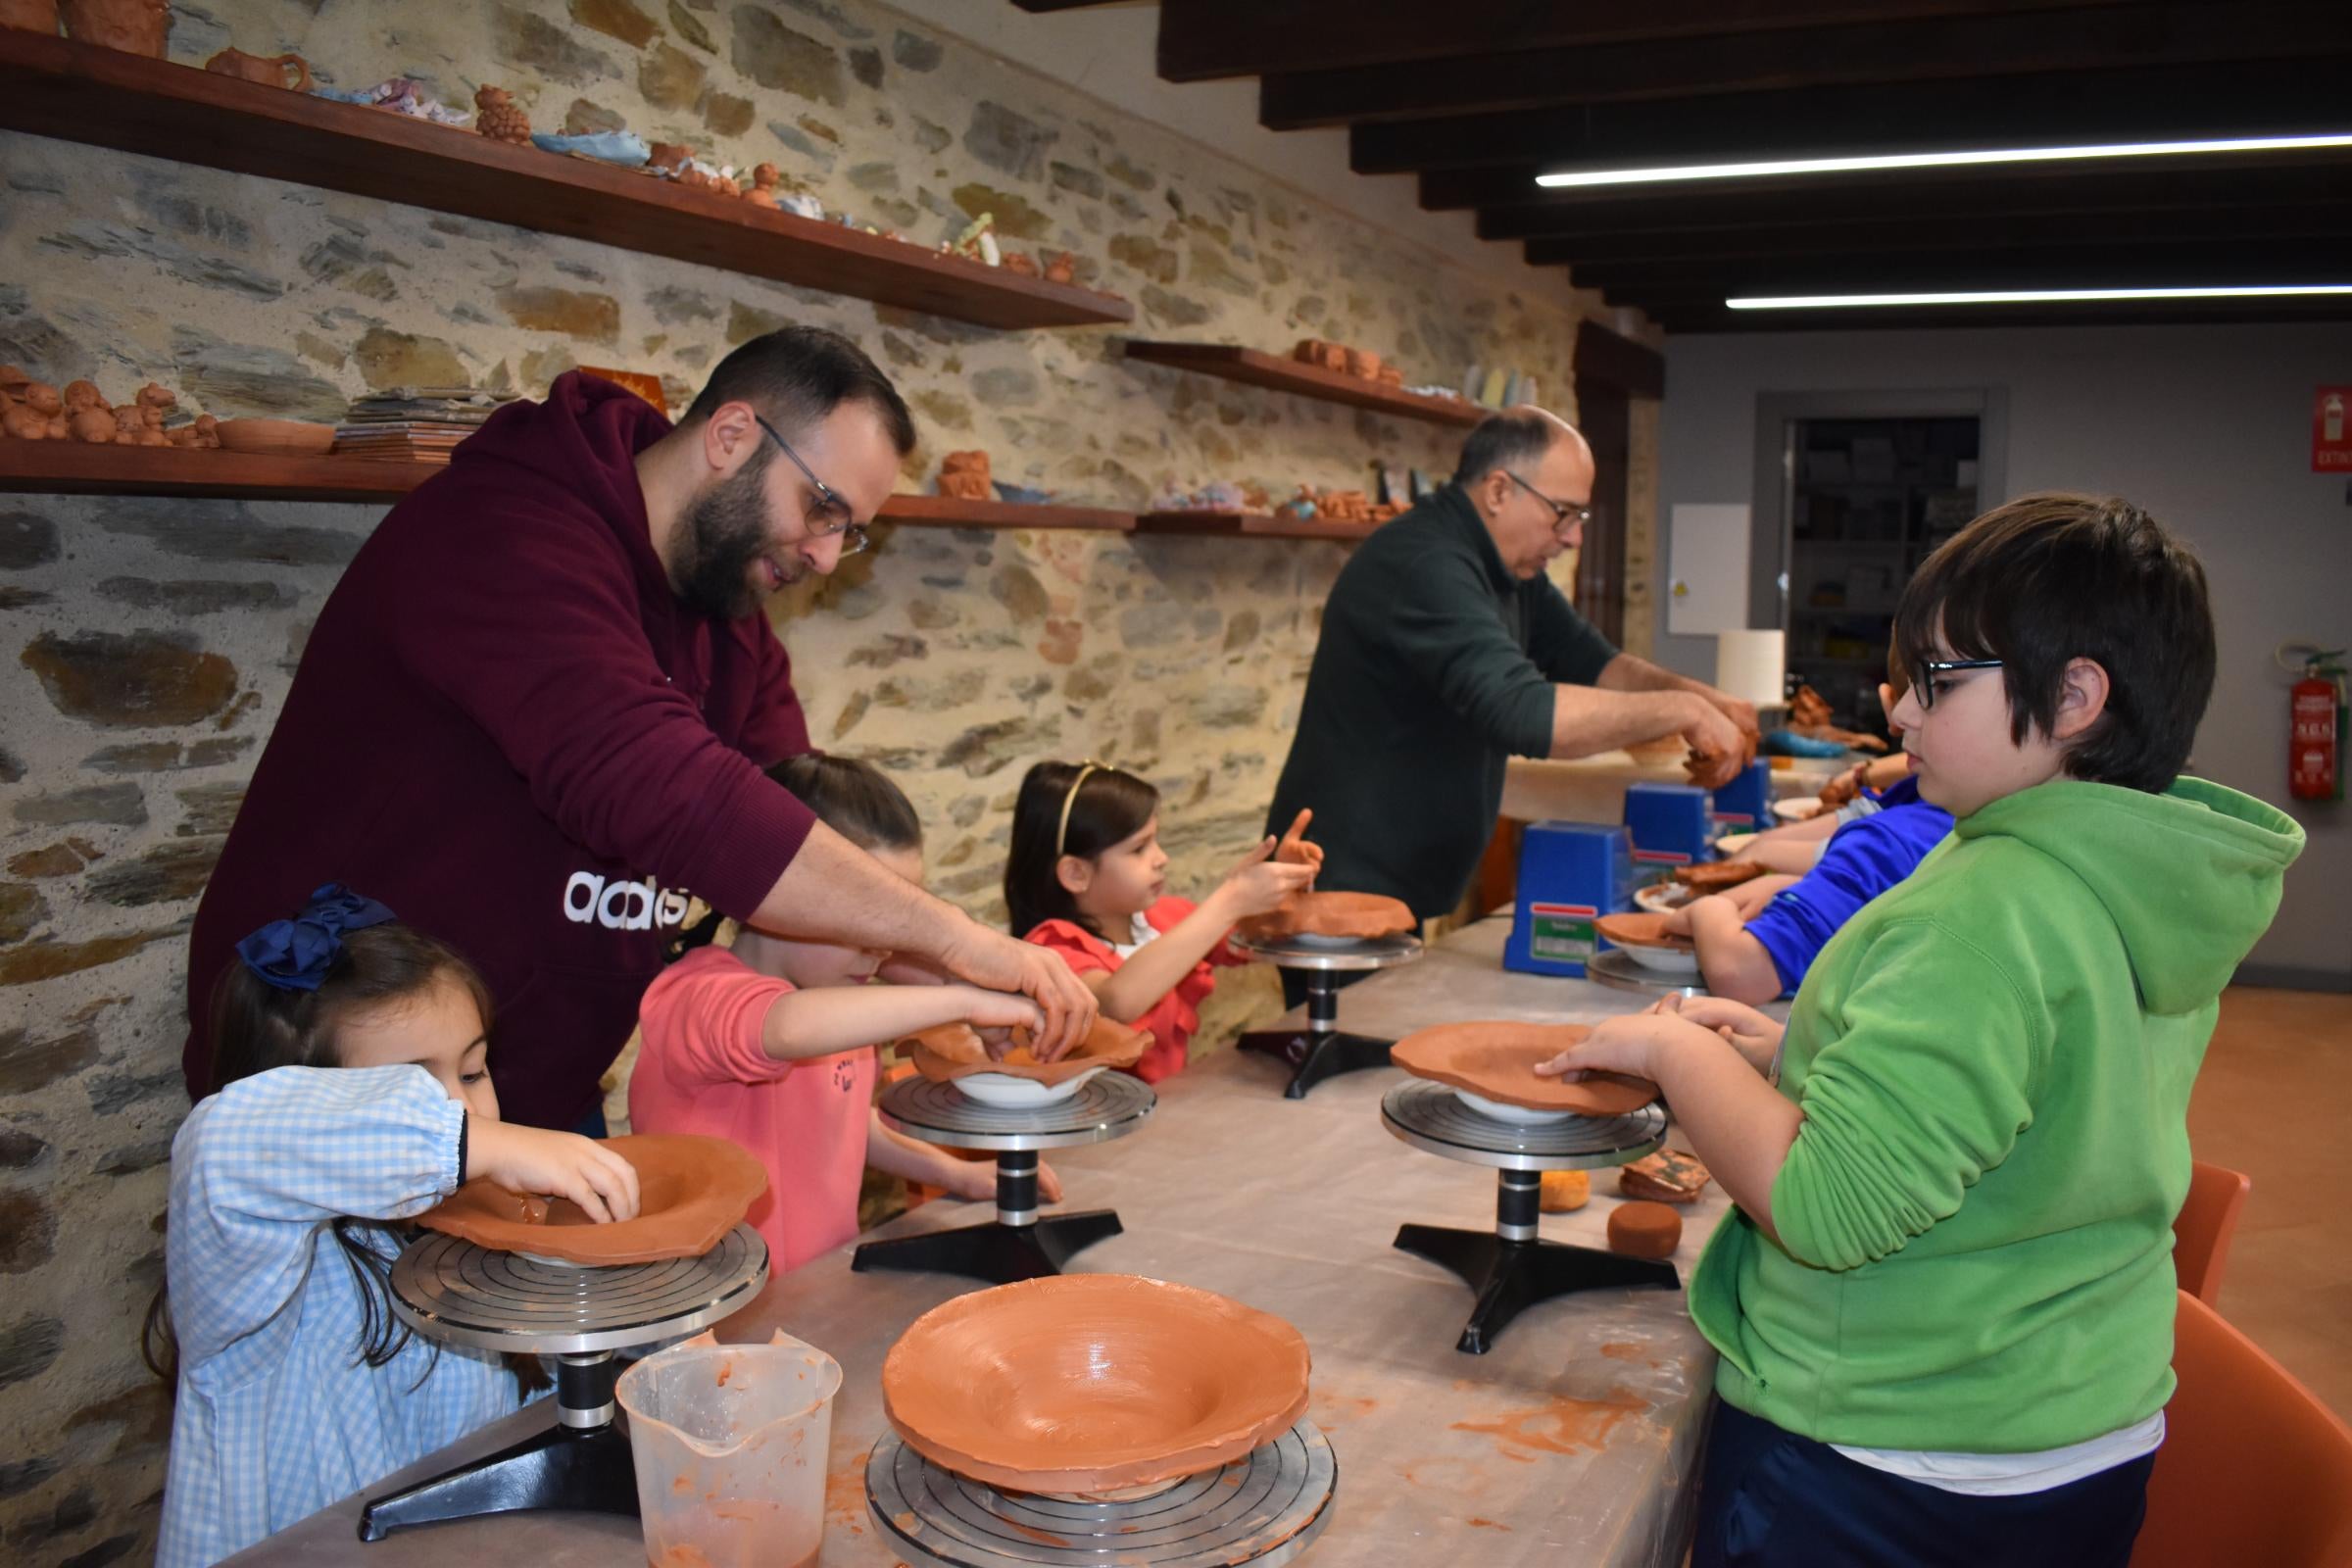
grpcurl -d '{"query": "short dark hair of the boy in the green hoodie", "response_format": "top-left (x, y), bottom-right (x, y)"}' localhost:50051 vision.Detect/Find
top-left (1895, 494), bottom-right (2213, 792)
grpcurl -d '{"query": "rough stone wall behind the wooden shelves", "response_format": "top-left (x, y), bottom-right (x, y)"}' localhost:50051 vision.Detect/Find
top-left (0, 0), bottom-right (1648, 1566)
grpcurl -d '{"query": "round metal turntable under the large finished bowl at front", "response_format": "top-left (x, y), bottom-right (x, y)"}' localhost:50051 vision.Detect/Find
top-left (865, 1420), bottom-right (1339, 1568)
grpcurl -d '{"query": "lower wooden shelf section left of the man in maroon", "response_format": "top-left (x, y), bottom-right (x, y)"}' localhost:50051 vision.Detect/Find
top-left (0, 440), bottom-right (440, 501)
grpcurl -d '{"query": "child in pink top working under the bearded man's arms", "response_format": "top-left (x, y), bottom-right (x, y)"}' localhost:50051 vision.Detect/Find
top-left (628, 755), bottom-right (1060, 1272)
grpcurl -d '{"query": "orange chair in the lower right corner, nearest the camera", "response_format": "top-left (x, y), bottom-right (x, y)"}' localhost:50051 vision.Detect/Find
top-left (2131, 1291), bottom-right (2352, 1568)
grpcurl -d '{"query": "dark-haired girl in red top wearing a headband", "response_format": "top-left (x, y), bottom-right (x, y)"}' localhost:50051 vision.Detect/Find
top-left (1004, 761), bottom-right (1315, 1084)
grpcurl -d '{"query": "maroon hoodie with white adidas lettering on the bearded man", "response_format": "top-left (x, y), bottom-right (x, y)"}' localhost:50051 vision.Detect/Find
top-left (183, 371), bottom-right (813, 1126)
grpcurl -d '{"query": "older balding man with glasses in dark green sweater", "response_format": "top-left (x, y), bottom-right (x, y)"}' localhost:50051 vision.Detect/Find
top-left (1268, 407), bottom-right (1757, 940)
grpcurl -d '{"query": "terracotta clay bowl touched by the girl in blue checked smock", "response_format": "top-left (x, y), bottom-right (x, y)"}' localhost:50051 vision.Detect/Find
top-left (416, 1133), bottom-right (766, 1267)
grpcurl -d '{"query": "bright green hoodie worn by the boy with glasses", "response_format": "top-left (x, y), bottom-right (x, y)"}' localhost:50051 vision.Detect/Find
top-left (1691, 778), bottom-right (2303, 1452)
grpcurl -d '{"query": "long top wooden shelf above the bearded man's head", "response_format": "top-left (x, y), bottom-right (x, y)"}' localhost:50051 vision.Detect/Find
top-left (0, 28), bottom-right (1136, 329)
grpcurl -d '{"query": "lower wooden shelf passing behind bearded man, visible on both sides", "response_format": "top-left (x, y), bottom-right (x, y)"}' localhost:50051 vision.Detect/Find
top-left (0, 440), bottom-right (1136, 534)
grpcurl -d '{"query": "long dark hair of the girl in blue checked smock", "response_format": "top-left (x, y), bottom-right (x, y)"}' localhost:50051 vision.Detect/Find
top-left (139, 921), bottom-right (548, 1396)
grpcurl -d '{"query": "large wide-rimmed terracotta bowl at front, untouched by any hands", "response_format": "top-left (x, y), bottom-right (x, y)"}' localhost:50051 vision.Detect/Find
top-left (882, 1274), bottom-right (1307, 1497)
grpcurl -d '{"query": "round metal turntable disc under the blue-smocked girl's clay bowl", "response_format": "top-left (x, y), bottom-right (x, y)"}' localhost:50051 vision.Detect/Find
top-left (393, 1225), bottom-right (766, 1356)
